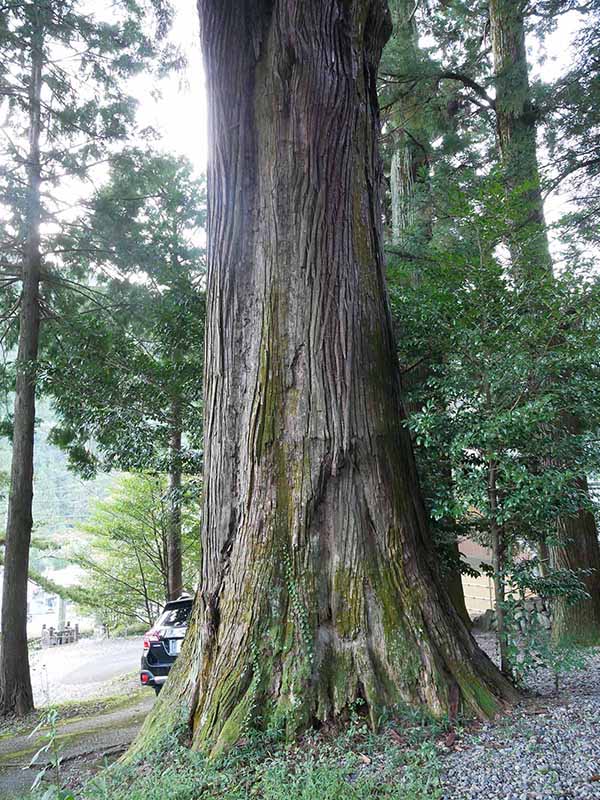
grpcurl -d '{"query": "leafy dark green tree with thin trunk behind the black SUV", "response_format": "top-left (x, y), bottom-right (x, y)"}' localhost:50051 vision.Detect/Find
top-left (41, 149), bottom-right (206, 599)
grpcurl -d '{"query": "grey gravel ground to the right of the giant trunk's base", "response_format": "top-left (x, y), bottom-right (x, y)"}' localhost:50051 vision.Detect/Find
top-left (442, 635), bottom-right (600, 800)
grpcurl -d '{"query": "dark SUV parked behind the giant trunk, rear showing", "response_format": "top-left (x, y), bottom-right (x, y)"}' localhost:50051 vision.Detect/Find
top-left (140, 595), bottom-right (194, 694)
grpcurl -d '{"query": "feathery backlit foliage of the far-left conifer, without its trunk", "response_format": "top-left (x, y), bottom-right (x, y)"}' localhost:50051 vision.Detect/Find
top-left (0, 0), bottom-right (181, 334)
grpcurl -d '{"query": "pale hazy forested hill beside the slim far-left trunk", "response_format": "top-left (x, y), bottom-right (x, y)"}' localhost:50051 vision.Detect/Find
top-left (0, 401), bottom-right (116, 569)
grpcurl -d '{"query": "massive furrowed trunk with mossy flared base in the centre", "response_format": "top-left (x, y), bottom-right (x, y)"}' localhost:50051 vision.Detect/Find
top-left (136, 0), bottom-right (512, 753)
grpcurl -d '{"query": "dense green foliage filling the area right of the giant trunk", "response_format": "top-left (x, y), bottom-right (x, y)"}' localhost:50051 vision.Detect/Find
top-left (381, 0), bottom-right (600, 672)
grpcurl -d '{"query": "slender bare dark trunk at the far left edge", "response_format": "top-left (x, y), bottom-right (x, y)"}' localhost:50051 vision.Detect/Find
top-left (0, 12), bottom-right (43, 716)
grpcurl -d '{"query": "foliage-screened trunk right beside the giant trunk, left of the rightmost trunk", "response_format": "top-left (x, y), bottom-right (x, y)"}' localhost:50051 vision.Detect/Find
top-left (390, 0), bottom-right (471, 626)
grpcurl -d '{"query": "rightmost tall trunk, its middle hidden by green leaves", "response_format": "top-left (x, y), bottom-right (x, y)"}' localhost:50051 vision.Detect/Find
top-left (490, 0), bottom-right (600, 644)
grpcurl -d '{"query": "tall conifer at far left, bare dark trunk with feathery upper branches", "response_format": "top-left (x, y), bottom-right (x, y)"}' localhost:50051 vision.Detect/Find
top-left (0, 0), bottom-right (176, 714)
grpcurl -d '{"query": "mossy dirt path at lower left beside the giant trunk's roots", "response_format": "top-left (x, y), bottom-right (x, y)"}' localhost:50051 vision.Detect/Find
top-left (0, 691), bottom-right (155, 800)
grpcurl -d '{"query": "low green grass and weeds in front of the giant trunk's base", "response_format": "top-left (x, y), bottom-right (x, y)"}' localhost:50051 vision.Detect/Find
top-left (31, 717), bottom-right (444, 800)
